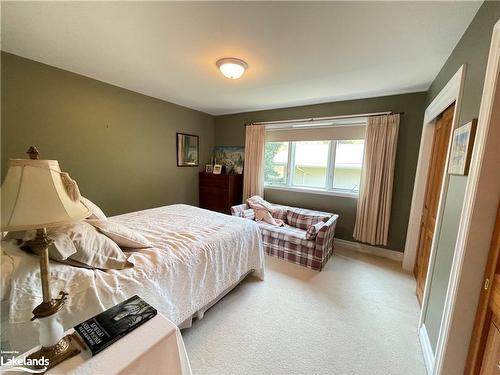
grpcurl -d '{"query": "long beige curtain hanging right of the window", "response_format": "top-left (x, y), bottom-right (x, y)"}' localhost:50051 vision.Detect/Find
top-left (354, 114), bottom-right (399, 245)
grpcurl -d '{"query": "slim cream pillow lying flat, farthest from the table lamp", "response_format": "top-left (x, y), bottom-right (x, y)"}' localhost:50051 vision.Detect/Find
top-left (86, 219), bottom-right (153, 249)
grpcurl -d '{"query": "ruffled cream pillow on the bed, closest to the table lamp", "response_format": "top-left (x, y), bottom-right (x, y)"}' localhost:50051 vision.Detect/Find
top-left (49, 222), bottom-right (133, 270)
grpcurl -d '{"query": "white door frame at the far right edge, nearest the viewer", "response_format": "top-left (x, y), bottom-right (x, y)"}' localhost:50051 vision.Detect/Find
top-left (433, 21), bottom-right (500, 374)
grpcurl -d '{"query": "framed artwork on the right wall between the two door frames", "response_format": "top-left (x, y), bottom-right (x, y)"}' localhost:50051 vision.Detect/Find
top-left (448, 119), bottom-right (477, 176)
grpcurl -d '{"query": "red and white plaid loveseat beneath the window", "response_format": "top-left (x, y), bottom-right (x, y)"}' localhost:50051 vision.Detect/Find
top-left (231, 204), bottom-right (339, 271)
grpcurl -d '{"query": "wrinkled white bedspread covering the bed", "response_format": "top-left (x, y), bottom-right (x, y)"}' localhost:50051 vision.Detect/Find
top-left (3, 205), bottom-right (264, 352)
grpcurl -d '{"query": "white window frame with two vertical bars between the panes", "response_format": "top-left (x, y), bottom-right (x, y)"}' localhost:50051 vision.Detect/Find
top-left (264, 139), bottom-right (364, 198)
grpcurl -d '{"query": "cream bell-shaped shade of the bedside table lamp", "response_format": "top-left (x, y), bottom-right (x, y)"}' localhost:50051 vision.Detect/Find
top-left (1, 159), bottom-right (91, 231)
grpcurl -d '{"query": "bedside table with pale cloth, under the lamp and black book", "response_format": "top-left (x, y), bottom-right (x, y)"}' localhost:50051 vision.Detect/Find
top-left (2, 314), bottom-right (191, 375)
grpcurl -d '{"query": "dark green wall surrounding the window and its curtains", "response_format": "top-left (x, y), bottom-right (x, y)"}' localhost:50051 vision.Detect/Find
top-left (215, 92), bottom-right (426, 251)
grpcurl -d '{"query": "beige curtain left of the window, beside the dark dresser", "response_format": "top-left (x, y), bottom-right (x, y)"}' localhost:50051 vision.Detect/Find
top-left (243, 125), bottom-right (266, 202)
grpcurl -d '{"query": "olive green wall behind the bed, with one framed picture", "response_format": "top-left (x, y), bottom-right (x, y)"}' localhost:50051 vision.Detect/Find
top-left (1, 52), bottom-right (214, 215)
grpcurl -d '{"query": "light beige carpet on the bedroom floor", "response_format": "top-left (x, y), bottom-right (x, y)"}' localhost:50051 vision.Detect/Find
top-left (182, 250), bottom-right (425, 375)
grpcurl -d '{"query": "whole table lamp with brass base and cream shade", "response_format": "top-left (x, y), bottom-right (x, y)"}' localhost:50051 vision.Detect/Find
top-left (1, 147), bottom-right (91, 368)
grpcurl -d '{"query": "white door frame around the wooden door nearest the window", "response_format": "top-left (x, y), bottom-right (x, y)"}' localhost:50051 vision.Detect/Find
top-left (403, 65), bottom-right (466, 276)
